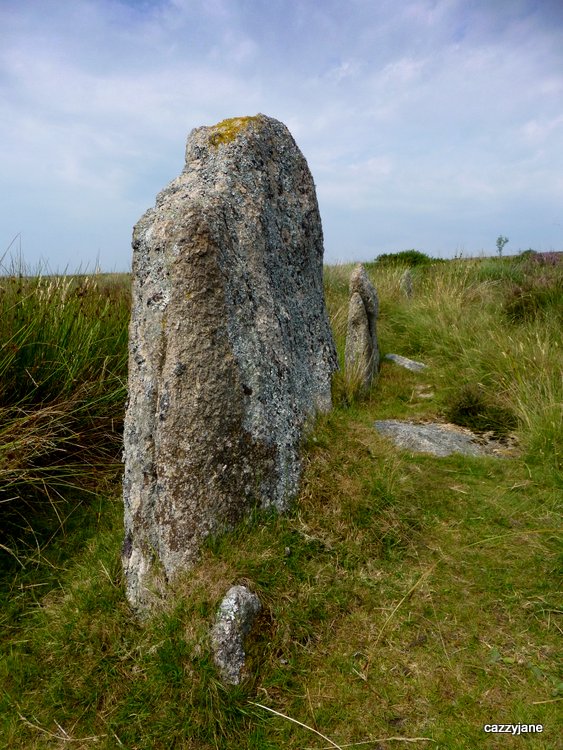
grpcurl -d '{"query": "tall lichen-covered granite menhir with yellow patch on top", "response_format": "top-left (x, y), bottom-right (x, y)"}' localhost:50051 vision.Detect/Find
top-left (123, 115), bottom-right (336, 611)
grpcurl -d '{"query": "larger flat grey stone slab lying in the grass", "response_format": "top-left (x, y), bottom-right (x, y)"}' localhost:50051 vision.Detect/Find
top-left (375, 419), bottom-right (510, 458)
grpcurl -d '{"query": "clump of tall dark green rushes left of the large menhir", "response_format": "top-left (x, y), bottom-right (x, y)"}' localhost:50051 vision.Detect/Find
top-left (0, 264), bottom-right (129, 550)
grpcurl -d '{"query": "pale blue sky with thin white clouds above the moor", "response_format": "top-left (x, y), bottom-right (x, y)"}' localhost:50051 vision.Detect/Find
top-left (0, 0), bottom-right (563, 272)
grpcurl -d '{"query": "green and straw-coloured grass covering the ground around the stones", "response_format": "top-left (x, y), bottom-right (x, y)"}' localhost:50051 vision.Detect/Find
top-left (0, 251), bottom-right (563, 750)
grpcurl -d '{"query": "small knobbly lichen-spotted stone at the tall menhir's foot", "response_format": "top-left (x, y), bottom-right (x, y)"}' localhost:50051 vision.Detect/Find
top-left (211, 586), bottom-right (262, 685)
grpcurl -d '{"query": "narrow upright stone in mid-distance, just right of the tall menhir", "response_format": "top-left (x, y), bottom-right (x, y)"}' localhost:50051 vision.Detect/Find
top-left (344, 263), bottom-right (379, 388)
